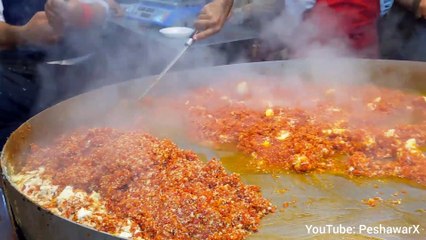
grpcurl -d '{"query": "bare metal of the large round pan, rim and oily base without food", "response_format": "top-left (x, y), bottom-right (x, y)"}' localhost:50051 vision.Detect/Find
top-left (1, 59), bottom-right (426, 240)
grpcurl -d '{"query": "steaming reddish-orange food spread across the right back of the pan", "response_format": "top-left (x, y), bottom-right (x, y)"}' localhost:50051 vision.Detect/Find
top-left (162, 81), bottom-right (426, 185)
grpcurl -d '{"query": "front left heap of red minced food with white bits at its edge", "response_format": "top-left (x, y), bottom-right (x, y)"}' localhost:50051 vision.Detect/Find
top-left (12, 128), bottom-right (274, 239)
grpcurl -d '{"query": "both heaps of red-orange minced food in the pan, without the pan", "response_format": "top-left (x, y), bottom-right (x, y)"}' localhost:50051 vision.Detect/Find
top-left (6, 78), bottom-right (426, 239)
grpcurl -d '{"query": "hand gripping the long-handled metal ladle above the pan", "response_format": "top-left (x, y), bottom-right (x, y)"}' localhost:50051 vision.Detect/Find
top-left (194, 0), bottom-right (234, 40)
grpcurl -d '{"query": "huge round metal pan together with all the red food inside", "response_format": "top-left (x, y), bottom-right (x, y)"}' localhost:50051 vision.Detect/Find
top-left (2, 61), bottom-right (426, 240)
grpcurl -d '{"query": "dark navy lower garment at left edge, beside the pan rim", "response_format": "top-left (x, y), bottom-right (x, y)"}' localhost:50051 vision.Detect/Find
top-left (0, 48), bottom-right (70, 149)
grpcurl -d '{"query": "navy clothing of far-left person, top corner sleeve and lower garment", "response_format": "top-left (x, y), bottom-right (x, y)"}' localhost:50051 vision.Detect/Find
top-left (0, 0), bottom-right (46, 146)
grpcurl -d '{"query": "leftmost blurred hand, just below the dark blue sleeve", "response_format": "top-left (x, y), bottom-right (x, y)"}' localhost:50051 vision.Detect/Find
top-left (19, 12), bottom-right (60, 45)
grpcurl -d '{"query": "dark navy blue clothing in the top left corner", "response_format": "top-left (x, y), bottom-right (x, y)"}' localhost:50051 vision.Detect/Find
top-left (2, 0), bottom-right (46, 25)
